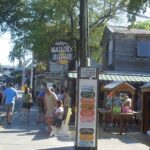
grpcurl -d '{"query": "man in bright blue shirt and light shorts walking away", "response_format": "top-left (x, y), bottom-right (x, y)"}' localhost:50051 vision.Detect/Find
top-left (3, 83), bottom-right (17, 124)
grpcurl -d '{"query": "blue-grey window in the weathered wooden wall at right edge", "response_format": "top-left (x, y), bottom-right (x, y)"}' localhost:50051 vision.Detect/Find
top-left (137, 39), bottom-right (150, 58)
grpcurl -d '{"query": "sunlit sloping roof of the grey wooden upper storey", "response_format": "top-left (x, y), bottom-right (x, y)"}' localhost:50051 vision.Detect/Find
top-left (107, 25), bottom-right (150, 35)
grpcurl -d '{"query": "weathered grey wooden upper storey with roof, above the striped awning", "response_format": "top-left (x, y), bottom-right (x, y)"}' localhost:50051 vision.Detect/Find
top-left (101, 26), bottom-right (150, 73)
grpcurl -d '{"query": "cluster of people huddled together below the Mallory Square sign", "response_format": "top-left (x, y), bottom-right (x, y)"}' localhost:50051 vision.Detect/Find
top-left (36, 87), bottom-right (71, 135)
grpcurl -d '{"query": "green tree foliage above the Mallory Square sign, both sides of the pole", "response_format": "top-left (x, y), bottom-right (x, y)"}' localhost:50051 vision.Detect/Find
top-left (0, 0), bottom-right (145, 63)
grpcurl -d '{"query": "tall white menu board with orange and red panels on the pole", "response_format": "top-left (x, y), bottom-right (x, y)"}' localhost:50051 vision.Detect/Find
top-left (77, 79), bottom-right (97, 147)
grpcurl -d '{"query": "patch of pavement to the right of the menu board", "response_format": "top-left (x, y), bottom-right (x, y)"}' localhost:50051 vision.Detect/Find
top-left (98, 128), bottom-right (149, 150)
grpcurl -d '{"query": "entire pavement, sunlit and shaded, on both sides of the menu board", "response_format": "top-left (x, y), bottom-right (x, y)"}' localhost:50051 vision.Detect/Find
top-left (0, 98), bottom-right (150, 150)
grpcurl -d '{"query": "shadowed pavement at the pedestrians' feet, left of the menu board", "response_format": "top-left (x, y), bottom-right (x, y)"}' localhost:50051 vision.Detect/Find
top-left (0, 104), bottom-right (74, 142)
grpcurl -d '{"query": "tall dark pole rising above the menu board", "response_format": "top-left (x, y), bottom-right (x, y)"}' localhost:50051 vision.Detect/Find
top-left (80, 0), bottom-right (89, 67)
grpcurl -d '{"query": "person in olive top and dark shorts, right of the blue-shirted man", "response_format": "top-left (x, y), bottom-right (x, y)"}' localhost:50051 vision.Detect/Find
top-left (22, 87), bottom-right (32, 122)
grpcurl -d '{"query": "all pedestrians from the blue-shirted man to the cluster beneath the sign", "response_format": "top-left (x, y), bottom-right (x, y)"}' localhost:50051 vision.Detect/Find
top-left (2, 83), bottom-right (71, 135)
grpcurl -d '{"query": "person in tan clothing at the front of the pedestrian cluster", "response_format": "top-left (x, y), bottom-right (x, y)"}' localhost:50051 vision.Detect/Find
top-left (45, 87), bottom-right (58, 135)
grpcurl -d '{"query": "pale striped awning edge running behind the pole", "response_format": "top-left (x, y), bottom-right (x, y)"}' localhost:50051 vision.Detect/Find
top-left (68, 72), bottom-right (150, 82)
